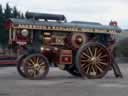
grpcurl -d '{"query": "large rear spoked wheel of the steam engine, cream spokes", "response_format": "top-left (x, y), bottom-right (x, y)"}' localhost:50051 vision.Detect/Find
top-left (76, 42), bottom-right (111, 79)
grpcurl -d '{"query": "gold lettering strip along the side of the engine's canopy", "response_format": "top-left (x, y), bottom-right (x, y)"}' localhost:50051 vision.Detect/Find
top-left (14, 24), bottom-right (116, 33)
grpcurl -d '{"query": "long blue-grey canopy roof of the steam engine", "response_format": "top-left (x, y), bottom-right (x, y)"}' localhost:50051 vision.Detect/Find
top-left (9, 18), bottom-right (121, 32)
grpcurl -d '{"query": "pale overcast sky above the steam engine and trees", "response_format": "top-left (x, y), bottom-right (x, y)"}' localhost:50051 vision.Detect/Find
top-left (0, 0), bottom-right (128, 29)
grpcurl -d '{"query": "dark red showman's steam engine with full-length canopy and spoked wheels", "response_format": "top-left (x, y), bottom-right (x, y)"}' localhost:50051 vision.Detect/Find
top-left (6, 12), bottom-right (121, 79)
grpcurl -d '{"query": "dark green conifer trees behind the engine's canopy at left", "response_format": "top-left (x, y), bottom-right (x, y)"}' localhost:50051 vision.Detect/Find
top-left (0, 3), bottom-right (24, 47)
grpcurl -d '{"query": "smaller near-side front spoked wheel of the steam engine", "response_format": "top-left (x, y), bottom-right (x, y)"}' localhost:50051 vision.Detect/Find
top-left (23, 54), bottom-right (49, 79)
